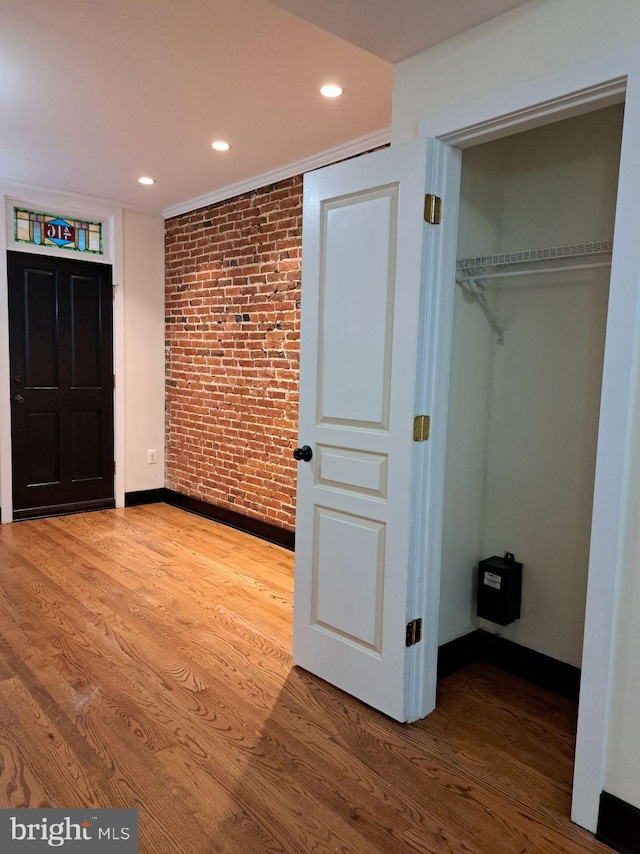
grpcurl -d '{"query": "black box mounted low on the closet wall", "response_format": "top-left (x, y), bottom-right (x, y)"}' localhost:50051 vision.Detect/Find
top-left (478, 552), bottom-right (522, 626)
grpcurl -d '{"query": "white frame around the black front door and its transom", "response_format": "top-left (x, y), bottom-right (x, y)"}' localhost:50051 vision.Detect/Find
top-left (0, 184), bottom-right (125, 523)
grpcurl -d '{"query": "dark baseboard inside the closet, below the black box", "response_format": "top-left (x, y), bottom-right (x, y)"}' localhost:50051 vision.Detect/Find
top-left (438, 629), bottom-right (580, 702)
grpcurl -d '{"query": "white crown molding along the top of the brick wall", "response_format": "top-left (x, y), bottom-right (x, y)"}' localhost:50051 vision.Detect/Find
top-left (162, 128), bottom-right (391, 219)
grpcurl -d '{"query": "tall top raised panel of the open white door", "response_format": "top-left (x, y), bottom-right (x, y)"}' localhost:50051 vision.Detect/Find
top-left (317, 184), bottom-right (398, 431)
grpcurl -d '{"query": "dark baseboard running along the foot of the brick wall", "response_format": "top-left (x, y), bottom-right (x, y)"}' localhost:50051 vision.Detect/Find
top-left (125, 489), bottom-right (295, 551)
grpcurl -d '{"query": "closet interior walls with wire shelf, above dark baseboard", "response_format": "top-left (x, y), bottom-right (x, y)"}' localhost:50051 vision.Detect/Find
top-left (439, 105), bottom-right (623, 667)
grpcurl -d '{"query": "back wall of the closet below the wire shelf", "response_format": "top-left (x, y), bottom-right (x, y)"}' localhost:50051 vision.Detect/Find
top-left (478, 271), bottom-right (608, 667)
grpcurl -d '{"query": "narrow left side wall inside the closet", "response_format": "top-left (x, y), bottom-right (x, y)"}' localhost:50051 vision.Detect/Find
top-left (438, 146), bottom-right (503, 644)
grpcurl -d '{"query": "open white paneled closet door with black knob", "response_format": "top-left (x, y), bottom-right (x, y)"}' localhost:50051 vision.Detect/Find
top-left (293, 141), bottom-right (442, 720)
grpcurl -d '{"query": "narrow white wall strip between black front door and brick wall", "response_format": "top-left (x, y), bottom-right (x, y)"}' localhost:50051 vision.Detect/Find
top-left (122, 211), bottom-right (164, 492)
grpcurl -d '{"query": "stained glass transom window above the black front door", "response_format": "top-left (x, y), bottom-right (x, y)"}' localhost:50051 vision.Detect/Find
top-left (13, 208), bottom-right (102, 255)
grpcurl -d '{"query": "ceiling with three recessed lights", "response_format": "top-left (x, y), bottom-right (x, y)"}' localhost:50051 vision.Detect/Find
top-left (0, 0), bottom-right (526, 213)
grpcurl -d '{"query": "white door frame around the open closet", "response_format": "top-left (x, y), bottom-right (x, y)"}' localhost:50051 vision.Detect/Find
top-left (418, 43), bottom-right (640, 832)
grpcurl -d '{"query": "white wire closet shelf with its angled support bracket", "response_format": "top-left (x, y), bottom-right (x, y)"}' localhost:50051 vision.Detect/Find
top-left (456, 238), bottom-right (613, 344)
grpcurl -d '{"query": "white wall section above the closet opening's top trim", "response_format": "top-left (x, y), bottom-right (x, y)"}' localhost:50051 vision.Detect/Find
top-left (391, 0), bottom-right (640, 145)
